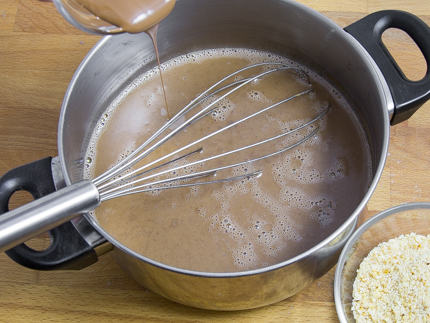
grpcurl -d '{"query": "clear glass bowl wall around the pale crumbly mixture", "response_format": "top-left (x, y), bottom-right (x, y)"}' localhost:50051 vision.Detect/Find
top-left (334, 203), bottom-right (430, 323)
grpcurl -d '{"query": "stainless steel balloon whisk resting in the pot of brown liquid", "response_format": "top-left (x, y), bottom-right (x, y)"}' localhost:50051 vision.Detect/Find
top-left (0, 62), bottom-right (329, 251)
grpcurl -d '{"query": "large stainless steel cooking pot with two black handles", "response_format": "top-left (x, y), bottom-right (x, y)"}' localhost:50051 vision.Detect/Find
top-left (0, 0), bottom-right (430, 310)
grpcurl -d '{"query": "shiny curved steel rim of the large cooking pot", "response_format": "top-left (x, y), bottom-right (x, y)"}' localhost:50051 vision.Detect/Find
top-left (57, 0), bottom-right (394, 278)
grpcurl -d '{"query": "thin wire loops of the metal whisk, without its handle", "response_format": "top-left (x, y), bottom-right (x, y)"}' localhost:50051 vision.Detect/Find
top-left (93, 63), bottom-right (330, 201)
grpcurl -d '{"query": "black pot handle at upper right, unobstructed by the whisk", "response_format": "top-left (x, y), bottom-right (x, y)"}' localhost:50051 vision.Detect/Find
top-left (345, 10), bottom-right (430, 125)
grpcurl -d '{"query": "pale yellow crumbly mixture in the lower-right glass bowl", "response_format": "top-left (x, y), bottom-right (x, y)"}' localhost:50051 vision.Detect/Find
top-left (352, 233), bottom-right (430, 323)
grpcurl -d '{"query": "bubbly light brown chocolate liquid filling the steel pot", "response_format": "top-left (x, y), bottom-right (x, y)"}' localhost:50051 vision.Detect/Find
top-left (85, 49), bottom-right (372, 272)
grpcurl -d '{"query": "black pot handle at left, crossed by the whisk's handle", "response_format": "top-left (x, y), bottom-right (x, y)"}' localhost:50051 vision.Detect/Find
top-left (0, 157), bottom-right (98, 270)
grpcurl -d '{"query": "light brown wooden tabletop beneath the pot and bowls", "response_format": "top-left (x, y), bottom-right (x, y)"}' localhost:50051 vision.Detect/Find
top-left (0, 0), bottom-right (430, 323)
